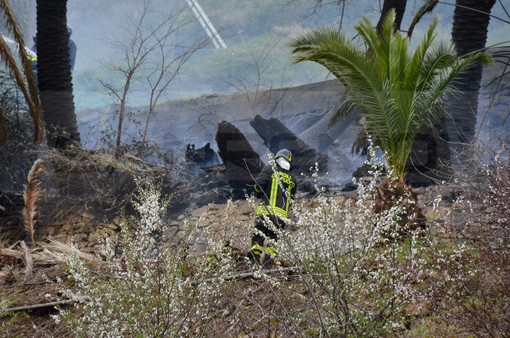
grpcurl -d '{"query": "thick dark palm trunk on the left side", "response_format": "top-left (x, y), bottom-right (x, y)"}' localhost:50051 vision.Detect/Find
top-left (37, 0), bottom-right (80, 149)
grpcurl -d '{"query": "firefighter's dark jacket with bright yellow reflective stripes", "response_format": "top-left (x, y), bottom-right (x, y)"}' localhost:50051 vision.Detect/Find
top-left (254, 165), bottom-right (297, 218)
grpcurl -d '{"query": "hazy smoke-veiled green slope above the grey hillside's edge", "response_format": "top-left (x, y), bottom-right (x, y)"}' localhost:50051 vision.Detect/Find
top-left (14, 0), bottom-right (509, 109)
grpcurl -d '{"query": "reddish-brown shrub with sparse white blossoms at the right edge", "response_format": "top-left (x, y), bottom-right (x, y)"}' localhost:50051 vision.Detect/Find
top-left (426, 152), bottom-right (510, 337)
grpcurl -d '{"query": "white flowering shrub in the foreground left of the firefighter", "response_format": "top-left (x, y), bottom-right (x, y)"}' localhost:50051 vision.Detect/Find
top-left (56, 181), bottom-right (230, 337)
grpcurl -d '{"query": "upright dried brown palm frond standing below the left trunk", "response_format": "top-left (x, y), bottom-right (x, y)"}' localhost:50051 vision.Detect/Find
top-left (23, 159), bottom-right (45, 244)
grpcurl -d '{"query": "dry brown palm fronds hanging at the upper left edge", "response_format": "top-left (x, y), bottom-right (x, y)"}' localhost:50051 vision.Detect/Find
top-left (0, 0), bottom-right (43, 143)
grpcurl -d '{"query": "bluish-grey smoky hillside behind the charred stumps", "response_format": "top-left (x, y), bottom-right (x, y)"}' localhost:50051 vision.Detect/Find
top-left (78, 57), bottom-right (510, 184)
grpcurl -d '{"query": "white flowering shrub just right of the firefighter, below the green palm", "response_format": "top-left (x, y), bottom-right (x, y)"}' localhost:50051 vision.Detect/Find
top-left (266, 152), bottom-right (438, 337)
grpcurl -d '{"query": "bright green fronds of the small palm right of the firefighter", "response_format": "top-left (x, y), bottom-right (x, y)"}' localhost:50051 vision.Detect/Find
top-left (291, 10), bottom-right (490, 183)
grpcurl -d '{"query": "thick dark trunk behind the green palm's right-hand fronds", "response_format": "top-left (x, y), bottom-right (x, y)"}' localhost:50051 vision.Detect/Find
top-left (446, 0), bottom-right (496, 162)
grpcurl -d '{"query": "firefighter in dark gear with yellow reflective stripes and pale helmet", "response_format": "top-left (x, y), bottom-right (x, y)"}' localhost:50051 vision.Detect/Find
top-left (248, 149), bottom-right (297, 267)
